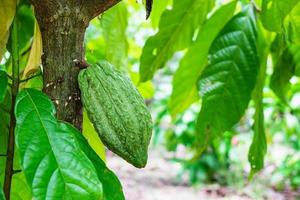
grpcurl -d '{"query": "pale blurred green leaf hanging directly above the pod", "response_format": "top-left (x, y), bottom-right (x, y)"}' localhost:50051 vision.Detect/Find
top-left (100, 2), bottom-right (128, 72)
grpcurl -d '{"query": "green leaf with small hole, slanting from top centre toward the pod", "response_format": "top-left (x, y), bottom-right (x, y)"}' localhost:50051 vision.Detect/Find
top-left (140, 0), bottom-right (214, 82)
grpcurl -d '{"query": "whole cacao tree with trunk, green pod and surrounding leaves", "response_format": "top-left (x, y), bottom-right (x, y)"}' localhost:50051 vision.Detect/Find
top-left (0, 0), bottom-right (300, 200)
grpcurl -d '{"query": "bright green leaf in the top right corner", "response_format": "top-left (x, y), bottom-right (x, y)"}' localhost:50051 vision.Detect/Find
top-left (261, 0), bottom-right (299, 32)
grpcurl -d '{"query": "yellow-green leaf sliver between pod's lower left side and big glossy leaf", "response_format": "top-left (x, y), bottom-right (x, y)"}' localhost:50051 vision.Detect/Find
top-left (82, 110), bottom-right (105, 160)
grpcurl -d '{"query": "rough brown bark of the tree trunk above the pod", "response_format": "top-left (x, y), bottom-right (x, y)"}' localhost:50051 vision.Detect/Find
top-left (31, 0), bottom-right (120, 129)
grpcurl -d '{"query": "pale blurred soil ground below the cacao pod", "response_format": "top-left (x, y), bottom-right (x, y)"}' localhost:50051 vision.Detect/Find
top-left (107, 150), bottom-right (296, 200)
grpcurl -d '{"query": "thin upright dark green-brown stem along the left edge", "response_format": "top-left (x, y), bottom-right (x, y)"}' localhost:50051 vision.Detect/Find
top-left (3, 12), bottom-right (19, 200)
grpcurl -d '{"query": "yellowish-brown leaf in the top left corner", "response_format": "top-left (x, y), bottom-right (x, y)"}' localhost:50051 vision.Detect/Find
top-left (0, 0), bottom-right (17, 61)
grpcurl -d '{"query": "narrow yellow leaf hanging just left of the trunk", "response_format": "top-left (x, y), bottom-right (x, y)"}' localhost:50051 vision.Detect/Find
top-left (23, 21), bottom-right (43, 78)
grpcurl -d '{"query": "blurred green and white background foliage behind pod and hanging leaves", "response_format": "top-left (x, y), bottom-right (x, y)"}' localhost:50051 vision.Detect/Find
top-left (0, 0), bottom-right (300, 199)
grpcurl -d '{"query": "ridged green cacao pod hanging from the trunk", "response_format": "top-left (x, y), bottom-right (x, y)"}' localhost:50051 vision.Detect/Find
top-left (79, 61), bottom-right (152, 168)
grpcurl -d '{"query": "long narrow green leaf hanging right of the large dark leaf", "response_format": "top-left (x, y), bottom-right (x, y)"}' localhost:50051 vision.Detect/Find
top-left (248, 23), bottom-right (270, 179)
